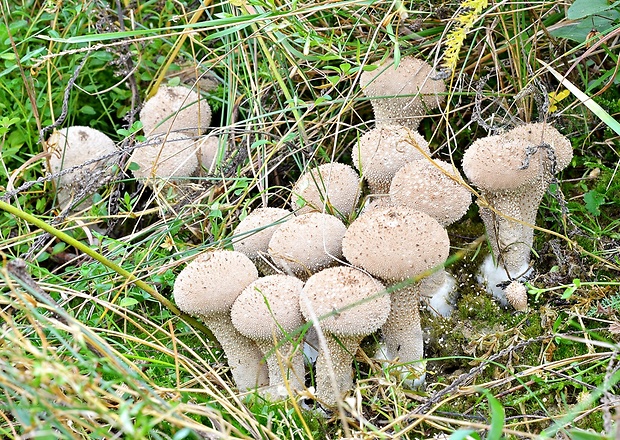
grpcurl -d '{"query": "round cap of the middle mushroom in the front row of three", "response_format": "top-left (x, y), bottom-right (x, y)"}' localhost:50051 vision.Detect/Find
top-left (231, 275), bottom-right (304, 340)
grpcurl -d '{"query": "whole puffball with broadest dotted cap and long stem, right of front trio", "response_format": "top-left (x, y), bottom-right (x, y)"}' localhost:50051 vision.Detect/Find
top-left (342, 206), bottom-right (450, 386)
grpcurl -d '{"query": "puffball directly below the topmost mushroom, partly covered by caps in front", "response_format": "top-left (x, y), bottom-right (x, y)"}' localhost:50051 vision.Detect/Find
top-left (352, 125), bottom-right (430, 194)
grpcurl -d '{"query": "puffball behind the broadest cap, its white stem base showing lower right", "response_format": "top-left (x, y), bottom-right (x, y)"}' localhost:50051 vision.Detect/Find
top-left (390, 159), bottom-right (471, 316)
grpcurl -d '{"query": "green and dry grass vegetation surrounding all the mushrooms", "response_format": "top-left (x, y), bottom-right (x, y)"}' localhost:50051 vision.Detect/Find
top-left (0, 0), bottom-right (620, 439)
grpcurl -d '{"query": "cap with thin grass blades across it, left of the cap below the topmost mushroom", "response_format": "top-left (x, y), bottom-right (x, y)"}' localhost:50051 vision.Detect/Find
top-left (291, 162), bottom-right (360, 218)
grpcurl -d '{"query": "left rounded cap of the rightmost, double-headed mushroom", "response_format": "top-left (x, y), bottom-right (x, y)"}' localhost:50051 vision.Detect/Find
top-left (463, 135), bottom-right (541, 192)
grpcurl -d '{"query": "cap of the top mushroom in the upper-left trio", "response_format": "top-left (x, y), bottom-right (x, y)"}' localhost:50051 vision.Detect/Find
top-left (140, 86), bottom-right (211, 136)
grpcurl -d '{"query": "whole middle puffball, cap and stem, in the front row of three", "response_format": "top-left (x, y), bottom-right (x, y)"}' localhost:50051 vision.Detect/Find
top-left (231, 275), bottom-right (305, 397)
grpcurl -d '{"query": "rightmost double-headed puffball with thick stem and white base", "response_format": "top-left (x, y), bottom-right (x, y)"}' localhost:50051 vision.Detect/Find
top-left (463, 123), bottom-right (573, 307)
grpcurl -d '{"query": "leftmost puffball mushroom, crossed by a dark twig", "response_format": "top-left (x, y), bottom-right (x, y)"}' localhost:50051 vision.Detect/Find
top-left (46, 126), bottom-right (116, 208)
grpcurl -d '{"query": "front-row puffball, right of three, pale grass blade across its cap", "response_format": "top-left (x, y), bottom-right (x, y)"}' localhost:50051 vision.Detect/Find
top-left (300, 266), bottom-right (390, 406)
